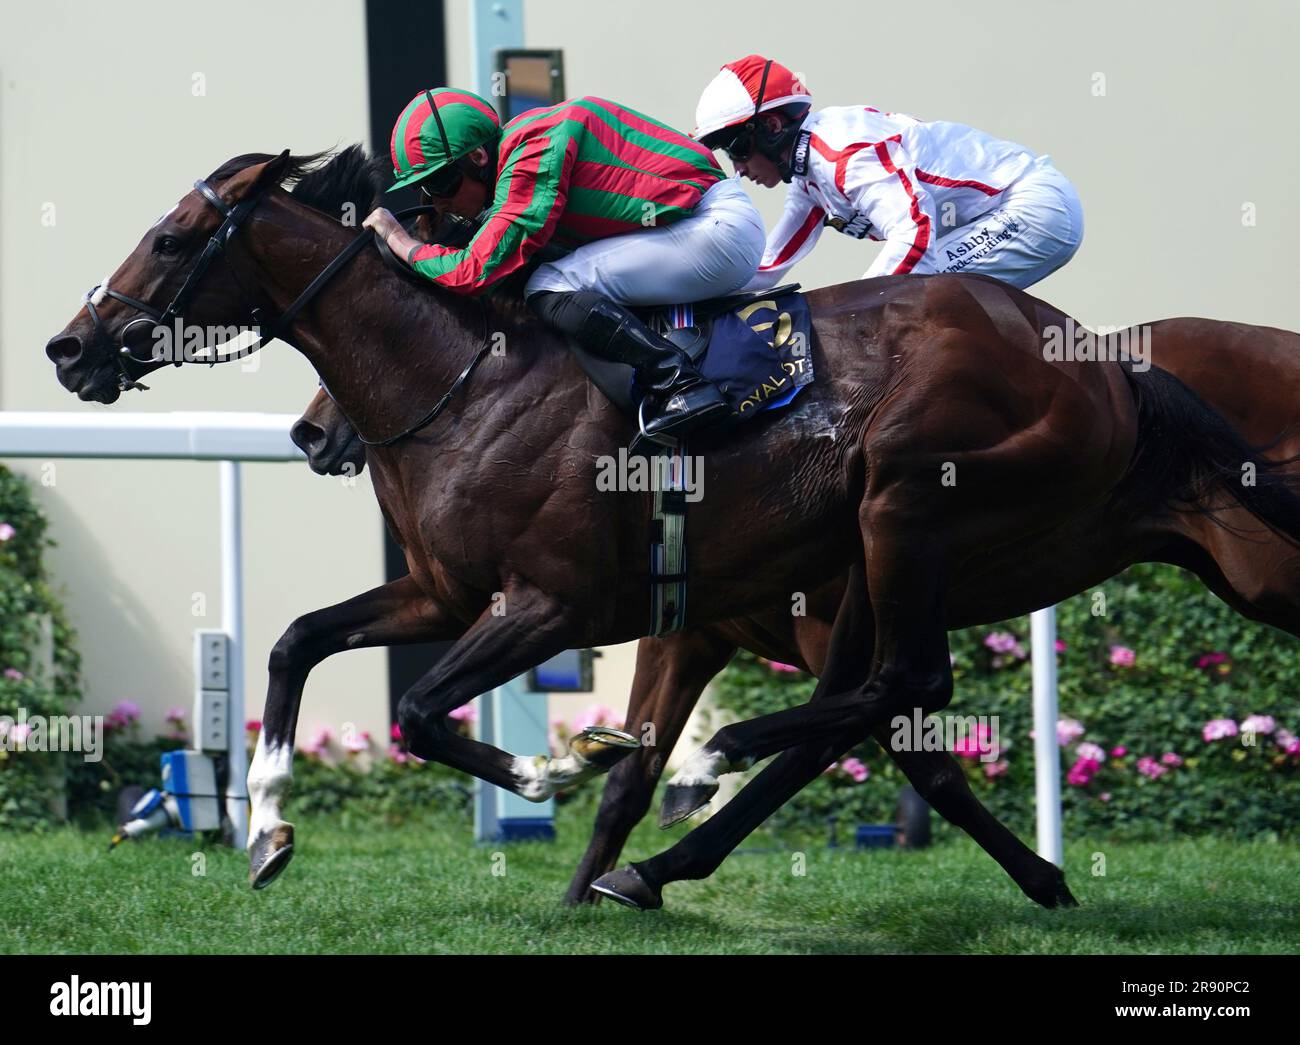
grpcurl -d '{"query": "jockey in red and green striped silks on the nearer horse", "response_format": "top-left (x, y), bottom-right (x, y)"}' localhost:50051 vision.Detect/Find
top-left (364, 87), bottom-right (764, 435)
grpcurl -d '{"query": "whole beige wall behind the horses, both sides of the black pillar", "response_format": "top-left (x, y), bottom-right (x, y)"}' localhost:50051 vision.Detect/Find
top-left (0, 0), bottom-right (1300, 753)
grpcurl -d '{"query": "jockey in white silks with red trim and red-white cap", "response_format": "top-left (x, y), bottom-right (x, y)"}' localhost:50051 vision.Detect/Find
top-left (694, 55), bottom-right (1083, 290)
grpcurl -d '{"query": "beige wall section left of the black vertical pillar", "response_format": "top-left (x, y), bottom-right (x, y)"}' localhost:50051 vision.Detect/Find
top-left (0, 0), bottom-right (387, 734)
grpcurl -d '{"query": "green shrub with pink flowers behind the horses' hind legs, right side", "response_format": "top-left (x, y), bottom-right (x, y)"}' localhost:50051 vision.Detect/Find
top-left (714, 565), bottom-right (1300, 837)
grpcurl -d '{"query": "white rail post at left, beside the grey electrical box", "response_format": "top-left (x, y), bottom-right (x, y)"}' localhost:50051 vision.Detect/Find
top-left (221, 461), bottom-right (248, 849)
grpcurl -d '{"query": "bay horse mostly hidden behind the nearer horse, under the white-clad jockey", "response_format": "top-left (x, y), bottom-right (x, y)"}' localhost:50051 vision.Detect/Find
top-left (294, 320), bottom-right (1300, 903)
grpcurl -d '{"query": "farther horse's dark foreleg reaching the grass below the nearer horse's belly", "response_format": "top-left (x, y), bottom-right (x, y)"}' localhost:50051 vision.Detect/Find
top-left (564, 632), bottom-right (736, 905)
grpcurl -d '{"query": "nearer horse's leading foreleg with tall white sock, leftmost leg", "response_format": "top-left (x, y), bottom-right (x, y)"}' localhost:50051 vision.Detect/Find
top-left (248, 577), bottom-right (464, 889)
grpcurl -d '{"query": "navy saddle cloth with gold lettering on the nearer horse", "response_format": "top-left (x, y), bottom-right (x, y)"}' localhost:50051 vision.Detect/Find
top-left (569, 283), bottom-right (813, 424)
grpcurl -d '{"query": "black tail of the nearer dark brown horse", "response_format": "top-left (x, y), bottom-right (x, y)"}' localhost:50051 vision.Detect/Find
top-left (1122, 365), bottom-right (1300, 546)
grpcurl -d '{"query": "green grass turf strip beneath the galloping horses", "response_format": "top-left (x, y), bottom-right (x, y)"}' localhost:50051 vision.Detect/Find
top-left (0, 811), bottom-right (1300, 954)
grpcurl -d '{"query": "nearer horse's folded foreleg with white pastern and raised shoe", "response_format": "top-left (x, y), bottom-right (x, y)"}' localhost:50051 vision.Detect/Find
top-left (398, 586), bottom-right (637, 802)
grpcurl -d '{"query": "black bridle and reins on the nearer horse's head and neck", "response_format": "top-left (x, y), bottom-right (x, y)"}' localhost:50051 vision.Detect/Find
top-left (83, 170), bottom-right (491, 446)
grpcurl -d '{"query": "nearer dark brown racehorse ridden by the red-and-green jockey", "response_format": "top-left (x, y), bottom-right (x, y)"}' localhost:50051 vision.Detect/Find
top-left (47, 144), bottom-right (1300, 906)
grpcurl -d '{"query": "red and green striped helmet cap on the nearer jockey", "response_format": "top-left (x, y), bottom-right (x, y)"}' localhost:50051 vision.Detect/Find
top-left (389, 87), bottom-right (501, 192)
